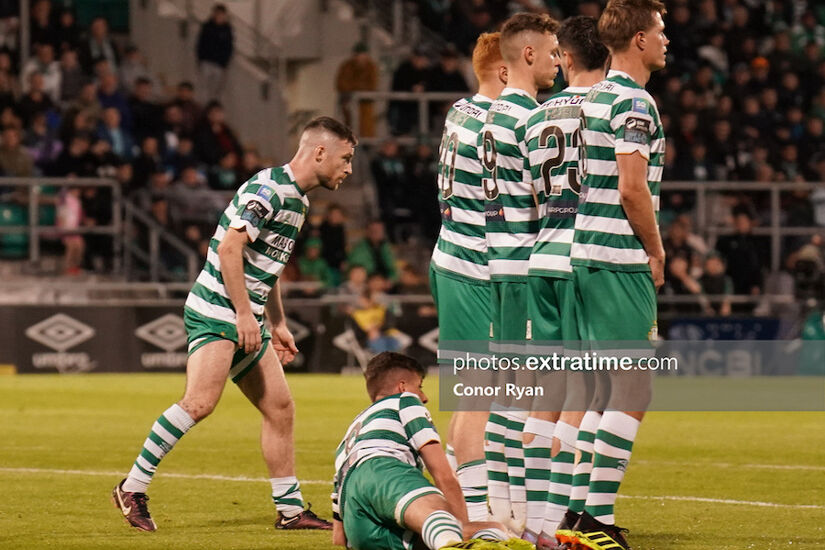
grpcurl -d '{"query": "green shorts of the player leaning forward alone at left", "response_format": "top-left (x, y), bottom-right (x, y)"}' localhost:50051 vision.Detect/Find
top-left (183, 307), bottom-right (272, 384)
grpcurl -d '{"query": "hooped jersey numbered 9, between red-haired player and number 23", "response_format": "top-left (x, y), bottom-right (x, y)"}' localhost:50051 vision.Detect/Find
top-left (478, 88), bottom-right (539, 282)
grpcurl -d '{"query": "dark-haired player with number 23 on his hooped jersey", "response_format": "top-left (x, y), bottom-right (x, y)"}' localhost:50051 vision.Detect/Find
top-left (523, 16), bottom-right (608, 548)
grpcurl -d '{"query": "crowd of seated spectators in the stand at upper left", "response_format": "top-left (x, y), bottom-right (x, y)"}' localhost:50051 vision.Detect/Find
top-left (0, 0), bottom-right (249, 273)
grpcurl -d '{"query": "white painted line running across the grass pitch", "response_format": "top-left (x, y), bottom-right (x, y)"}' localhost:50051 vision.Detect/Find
top-left (0, 467), bottom-right (825, 510)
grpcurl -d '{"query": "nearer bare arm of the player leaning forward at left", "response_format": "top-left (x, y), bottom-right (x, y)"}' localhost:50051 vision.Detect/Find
top-left (218, 227), bottom-right (261, 353)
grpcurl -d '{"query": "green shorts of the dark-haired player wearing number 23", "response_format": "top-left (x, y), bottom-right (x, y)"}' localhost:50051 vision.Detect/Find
top-left (527, 277), bottom-right (579, 345)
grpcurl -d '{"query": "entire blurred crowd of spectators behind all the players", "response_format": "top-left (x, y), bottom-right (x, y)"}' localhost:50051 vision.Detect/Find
top-left (0, 0), bottom-right (825, 324)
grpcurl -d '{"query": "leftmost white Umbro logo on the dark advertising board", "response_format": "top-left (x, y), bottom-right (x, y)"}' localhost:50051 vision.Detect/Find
top-left (26, 313), bottom-right (96, 372)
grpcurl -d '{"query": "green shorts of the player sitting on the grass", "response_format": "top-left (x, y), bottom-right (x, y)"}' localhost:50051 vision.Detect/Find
top-left (341, 457), bottom-right (442, 550)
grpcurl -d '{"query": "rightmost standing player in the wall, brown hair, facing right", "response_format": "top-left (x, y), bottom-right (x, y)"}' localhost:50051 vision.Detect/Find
top-left (570, 0), bottom-right (668, 550)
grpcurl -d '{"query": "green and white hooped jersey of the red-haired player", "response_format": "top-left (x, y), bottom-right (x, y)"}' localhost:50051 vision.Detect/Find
top-left (432, 94), bottom-right (493, 281)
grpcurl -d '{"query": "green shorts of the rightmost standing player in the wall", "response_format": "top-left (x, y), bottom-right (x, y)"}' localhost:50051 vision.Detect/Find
top-left (573, 266), bottom-right (657, 352)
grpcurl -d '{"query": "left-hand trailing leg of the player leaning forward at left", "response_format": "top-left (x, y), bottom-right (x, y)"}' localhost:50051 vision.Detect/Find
top-left (113, 339), bottom-right (235, 531)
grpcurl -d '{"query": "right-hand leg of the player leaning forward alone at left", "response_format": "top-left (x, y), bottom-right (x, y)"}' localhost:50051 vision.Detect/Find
top-left (233, 344), bottom-right (332, 529)
